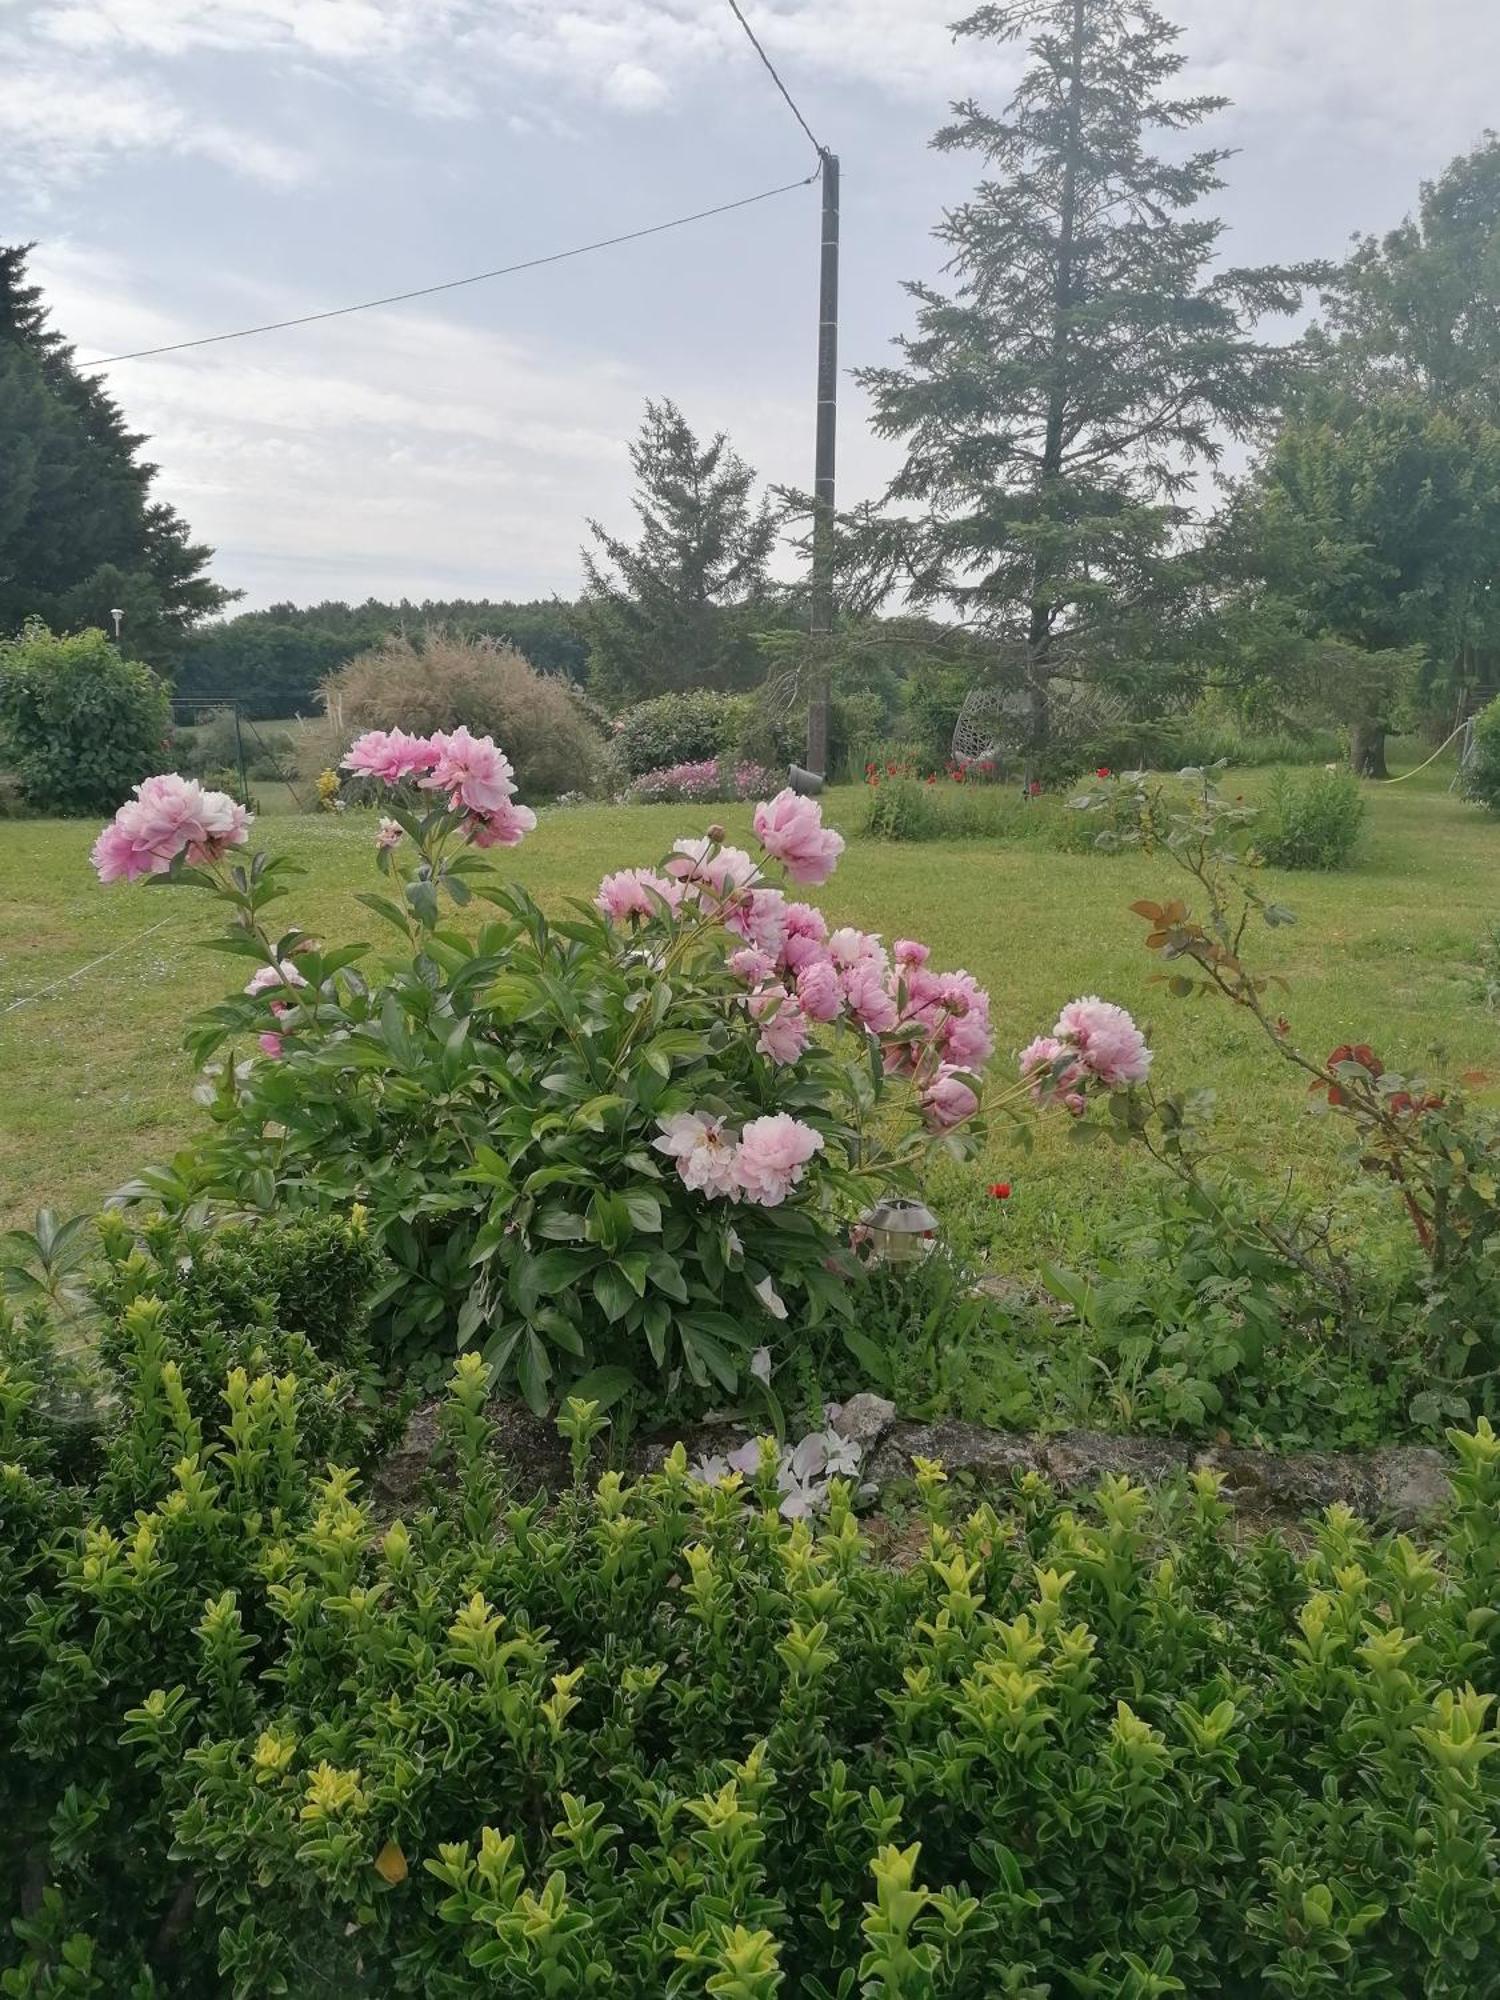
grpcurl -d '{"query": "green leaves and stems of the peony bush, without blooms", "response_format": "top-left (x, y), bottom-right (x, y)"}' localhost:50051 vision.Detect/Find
top-left (122, 794), bottom-right (964, 1410)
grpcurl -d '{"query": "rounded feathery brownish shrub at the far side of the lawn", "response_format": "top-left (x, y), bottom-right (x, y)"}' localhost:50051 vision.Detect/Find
top-left (324, 630), bottom-right (604, 798)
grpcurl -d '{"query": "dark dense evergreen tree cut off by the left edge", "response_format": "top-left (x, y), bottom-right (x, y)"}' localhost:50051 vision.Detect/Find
top-left (0, 244), bottom-right (232, 666)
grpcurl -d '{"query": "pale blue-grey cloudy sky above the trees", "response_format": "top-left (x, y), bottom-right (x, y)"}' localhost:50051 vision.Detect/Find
top-left (0, 0), bottom-right (1500, 606)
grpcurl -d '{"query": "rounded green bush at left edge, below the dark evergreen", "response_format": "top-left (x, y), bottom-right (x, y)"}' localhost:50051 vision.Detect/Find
top-left (0, 622), bottom-right (172, 816)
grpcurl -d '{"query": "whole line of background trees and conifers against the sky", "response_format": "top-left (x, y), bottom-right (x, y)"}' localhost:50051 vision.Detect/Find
top-left (0, 0), bottom-right (1500, 774)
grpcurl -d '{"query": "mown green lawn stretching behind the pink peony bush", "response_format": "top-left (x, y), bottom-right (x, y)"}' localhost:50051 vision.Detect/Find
top-left (0, 766), bottom-right (1500, 1264)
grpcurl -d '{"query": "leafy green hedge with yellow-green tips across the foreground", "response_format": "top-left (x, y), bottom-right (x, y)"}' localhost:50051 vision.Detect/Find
top-left (0, 1356), bottom-right (1500, 2000)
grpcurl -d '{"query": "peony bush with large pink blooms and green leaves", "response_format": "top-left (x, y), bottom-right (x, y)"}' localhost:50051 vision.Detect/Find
top-left (94, 728), bottom-right (1152, 1410)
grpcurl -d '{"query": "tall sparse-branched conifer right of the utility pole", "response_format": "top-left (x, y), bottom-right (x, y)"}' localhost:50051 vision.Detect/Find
top-left (860, 0), bottom-right (1316, 756)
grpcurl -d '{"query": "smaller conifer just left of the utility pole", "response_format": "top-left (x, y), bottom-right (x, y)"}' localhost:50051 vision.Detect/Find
top-left (580, 400), bottom-right (776, 702)
